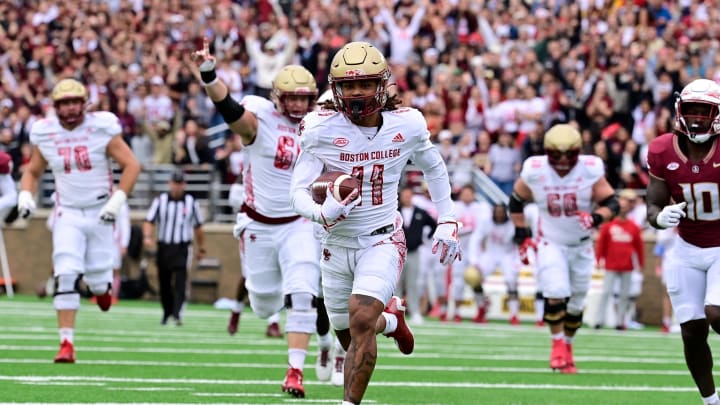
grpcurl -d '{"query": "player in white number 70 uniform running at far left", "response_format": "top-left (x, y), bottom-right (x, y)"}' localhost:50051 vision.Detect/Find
top-left (18, 79), bottom-right (140, 363)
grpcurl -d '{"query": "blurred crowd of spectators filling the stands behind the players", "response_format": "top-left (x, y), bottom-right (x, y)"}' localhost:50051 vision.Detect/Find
top-left (0, 0), bottom-right (720, 196)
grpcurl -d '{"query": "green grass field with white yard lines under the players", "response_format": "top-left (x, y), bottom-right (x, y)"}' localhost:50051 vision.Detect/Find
top-left (0, 296), bottom-right (718, 405)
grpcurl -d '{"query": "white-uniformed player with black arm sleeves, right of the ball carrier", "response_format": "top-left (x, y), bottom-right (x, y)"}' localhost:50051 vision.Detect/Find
top-left (508, 124), bottom-right (620, 374)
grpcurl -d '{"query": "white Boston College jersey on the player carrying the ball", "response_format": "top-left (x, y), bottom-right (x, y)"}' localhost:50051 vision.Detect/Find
top-left (300, 108), bottom-right (449, 237)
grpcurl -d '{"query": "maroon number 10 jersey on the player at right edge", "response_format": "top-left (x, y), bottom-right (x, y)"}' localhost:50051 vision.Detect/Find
top-left (648, 134), bottom-right (720, 248)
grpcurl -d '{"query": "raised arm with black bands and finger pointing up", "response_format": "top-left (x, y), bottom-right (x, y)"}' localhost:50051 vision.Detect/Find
top-left (191, 38), bottom-right (258, 145)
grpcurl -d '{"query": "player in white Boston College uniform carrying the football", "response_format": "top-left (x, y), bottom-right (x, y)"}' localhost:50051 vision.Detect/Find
top-left (291, 42), bottom-right (460, 404)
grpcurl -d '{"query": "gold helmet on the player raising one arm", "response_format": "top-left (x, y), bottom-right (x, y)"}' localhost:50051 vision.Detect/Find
top-left (272, 65), bottom-right (318, 122)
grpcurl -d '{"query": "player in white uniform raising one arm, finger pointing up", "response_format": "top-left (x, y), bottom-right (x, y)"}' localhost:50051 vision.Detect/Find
top-left (192, 38), bottom-right (332, 397)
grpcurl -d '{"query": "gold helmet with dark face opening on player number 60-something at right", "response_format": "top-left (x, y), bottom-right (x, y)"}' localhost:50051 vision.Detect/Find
top-left (543, 124), bottom-right (582, 176)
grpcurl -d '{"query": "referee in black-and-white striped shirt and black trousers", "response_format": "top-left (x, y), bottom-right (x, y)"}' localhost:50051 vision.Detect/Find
top-left (143, 171), bottom-right (205, 326)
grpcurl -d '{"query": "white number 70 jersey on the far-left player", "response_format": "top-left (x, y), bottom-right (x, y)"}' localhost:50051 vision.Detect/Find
top-left (30, 111), bottom-right (122, 208)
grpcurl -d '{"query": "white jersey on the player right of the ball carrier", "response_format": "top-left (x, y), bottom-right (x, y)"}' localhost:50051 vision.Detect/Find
top-left (520, 155), bottom-right (605, 245)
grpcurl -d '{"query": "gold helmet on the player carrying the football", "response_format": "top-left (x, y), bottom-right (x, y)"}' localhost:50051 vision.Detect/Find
top-left (328, 41), bottom-right (390, 119)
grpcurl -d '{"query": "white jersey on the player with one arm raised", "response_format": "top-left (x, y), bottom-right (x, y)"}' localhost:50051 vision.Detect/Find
top-left (241, 96), bottom-right (300, 218)
